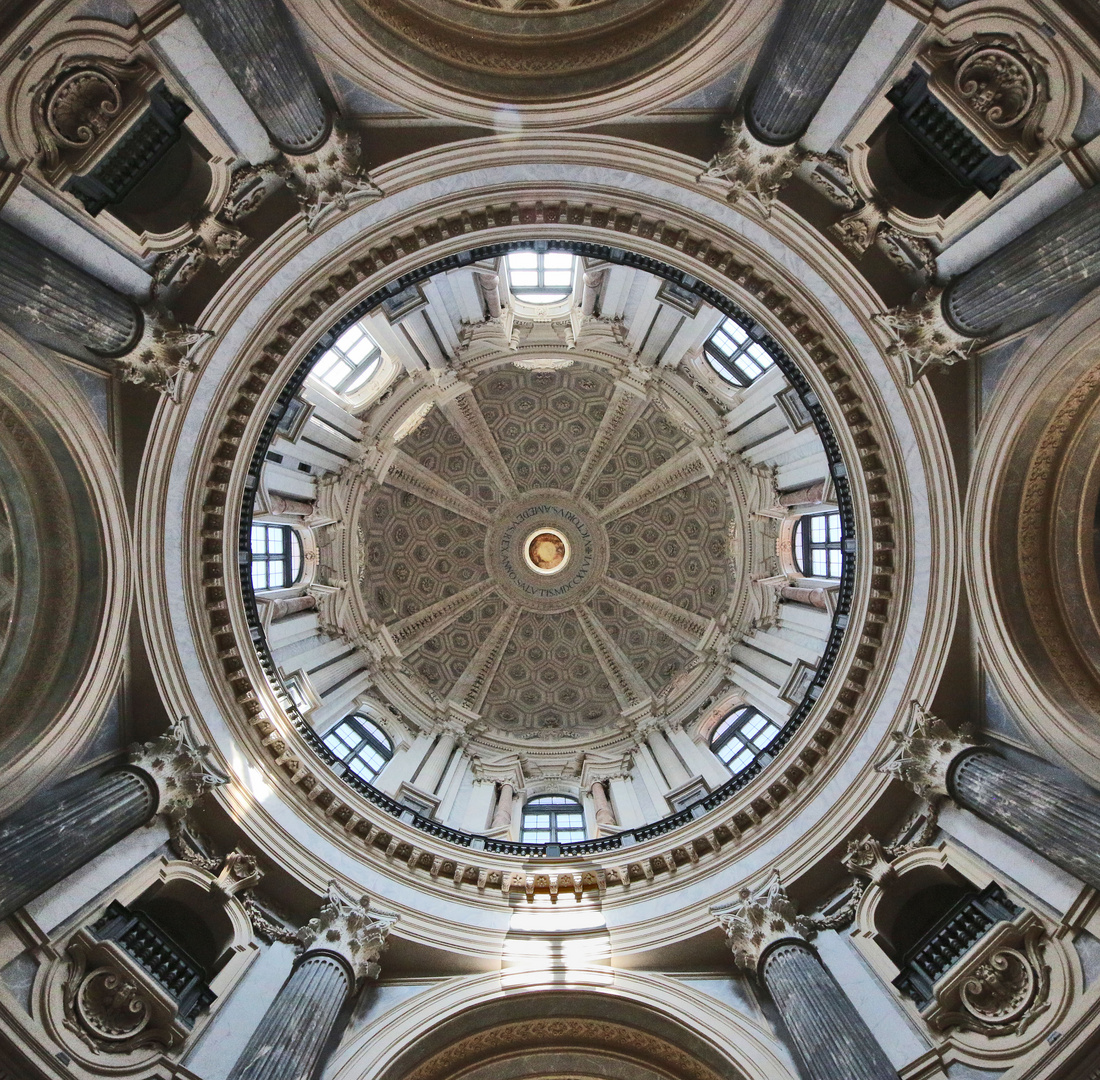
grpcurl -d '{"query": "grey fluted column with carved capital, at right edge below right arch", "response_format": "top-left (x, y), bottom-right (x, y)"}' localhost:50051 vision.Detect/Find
top-left (879, 705), bottom-right (1100, 889)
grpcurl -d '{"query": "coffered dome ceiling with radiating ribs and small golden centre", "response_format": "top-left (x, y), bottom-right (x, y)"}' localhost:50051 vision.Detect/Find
top-left (343, 361), bottom-right (746, 741)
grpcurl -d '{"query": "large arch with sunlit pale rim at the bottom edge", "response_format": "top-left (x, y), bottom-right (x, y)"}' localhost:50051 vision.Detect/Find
top-left (329, 971), bottom-right (794, 1080)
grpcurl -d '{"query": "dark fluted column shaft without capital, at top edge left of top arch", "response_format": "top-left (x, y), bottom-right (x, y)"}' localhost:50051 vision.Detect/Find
top-left (184, 0), bottom-right (332, 154)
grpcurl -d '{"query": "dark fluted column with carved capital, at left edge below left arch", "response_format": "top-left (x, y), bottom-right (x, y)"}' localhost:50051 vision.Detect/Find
top-left (0, 723), bottom-right (226, 918)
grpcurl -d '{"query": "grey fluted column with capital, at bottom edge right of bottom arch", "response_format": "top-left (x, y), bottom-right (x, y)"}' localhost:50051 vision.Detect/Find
top-left (711, 874), bottom-right (898, 1080)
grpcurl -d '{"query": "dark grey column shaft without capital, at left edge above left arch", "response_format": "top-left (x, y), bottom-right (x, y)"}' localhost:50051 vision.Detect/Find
top-left (0, 221), bottom-right (144, 356)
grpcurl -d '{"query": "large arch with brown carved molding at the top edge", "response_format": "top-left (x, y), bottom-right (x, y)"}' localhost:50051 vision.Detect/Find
top-left (290, 0), bottom-right (766, 131)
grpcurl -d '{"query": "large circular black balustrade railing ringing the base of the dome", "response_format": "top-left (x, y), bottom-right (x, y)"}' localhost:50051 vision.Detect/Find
top-left (238, 240), bottom-right (856, 859)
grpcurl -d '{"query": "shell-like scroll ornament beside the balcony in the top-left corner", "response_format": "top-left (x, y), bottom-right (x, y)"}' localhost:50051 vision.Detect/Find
top-left (31, 56), bottom-right (147, 169)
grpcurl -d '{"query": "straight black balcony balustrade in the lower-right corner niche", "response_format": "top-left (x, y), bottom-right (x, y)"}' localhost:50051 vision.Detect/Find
top-left (893, 883), bottom-right (1021, 1009)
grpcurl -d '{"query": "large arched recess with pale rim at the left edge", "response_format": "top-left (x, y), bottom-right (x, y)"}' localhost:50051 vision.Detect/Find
top-left (0, 327), bottom-right (131, 807)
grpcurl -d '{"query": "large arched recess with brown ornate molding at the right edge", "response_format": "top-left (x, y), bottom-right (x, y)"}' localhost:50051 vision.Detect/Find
top-left (966, 295), bottom-right (1100, 783)
